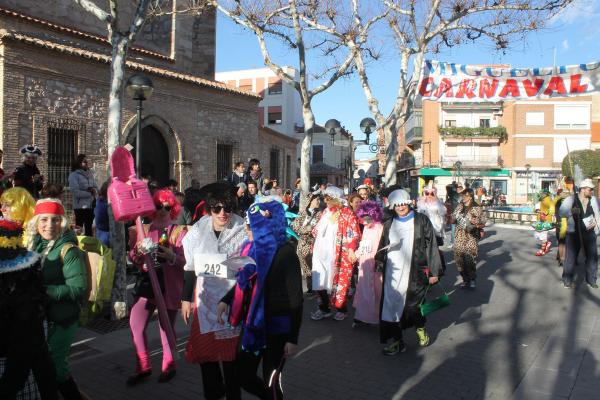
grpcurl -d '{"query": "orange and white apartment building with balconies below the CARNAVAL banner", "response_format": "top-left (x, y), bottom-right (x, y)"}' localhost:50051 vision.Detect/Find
top-left (399, 96), bottom-right (592, 203)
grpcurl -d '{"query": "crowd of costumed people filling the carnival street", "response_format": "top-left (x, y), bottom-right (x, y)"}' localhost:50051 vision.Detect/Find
top-left (0, 145), bottom-right (600, 399)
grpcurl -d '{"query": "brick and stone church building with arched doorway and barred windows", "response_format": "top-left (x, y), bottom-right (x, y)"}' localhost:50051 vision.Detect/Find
top-left (0, 0), bottom-right (296, 194)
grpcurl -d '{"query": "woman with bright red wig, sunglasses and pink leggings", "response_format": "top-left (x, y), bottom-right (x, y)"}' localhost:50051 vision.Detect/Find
top-left (127, 189), bottom-right (186, 386)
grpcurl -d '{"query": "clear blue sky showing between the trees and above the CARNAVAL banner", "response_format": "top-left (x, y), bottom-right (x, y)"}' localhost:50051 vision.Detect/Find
top-left (216, 0), bottom-right (600, 159)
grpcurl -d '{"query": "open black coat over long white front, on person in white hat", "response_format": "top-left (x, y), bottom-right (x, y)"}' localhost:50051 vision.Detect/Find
top-left (375, 211), bottom-right (443, 340)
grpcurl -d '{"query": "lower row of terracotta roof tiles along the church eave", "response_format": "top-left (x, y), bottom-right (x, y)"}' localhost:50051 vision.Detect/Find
top-left (0, 29), bottom-right (262, 99)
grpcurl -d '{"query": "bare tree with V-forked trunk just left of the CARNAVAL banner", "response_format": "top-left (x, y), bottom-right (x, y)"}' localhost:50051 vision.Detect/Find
top-left (346, 0), bottom-right (573, 185)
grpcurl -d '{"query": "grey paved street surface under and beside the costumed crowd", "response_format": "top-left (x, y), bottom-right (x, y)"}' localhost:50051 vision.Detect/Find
top-left (72, 227), bottom-right (600, 400)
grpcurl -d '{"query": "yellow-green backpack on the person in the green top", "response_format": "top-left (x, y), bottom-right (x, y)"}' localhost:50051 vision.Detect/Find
top-left (60, 236), bottom-right (116, 325)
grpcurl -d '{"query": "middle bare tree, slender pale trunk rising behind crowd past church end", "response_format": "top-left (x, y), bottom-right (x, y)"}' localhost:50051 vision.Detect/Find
top-left (209, 0), bottom-right (384, 200)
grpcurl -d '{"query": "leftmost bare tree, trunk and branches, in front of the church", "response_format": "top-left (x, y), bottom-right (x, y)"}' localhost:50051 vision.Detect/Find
top-left (72, 0), bottom-right (152, 318)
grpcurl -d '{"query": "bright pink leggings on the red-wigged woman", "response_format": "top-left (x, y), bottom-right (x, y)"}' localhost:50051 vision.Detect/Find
top-left (129, 297), bottom-right (177, 372)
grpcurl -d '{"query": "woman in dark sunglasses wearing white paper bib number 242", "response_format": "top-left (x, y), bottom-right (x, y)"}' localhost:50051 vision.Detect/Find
top-left (181, 182), bottom-right (247, 400)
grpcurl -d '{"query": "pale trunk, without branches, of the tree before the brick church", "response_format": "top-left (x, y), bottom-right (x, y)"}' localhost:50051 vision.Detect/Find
top-left (107, 36), bottom-right (129, 319)
